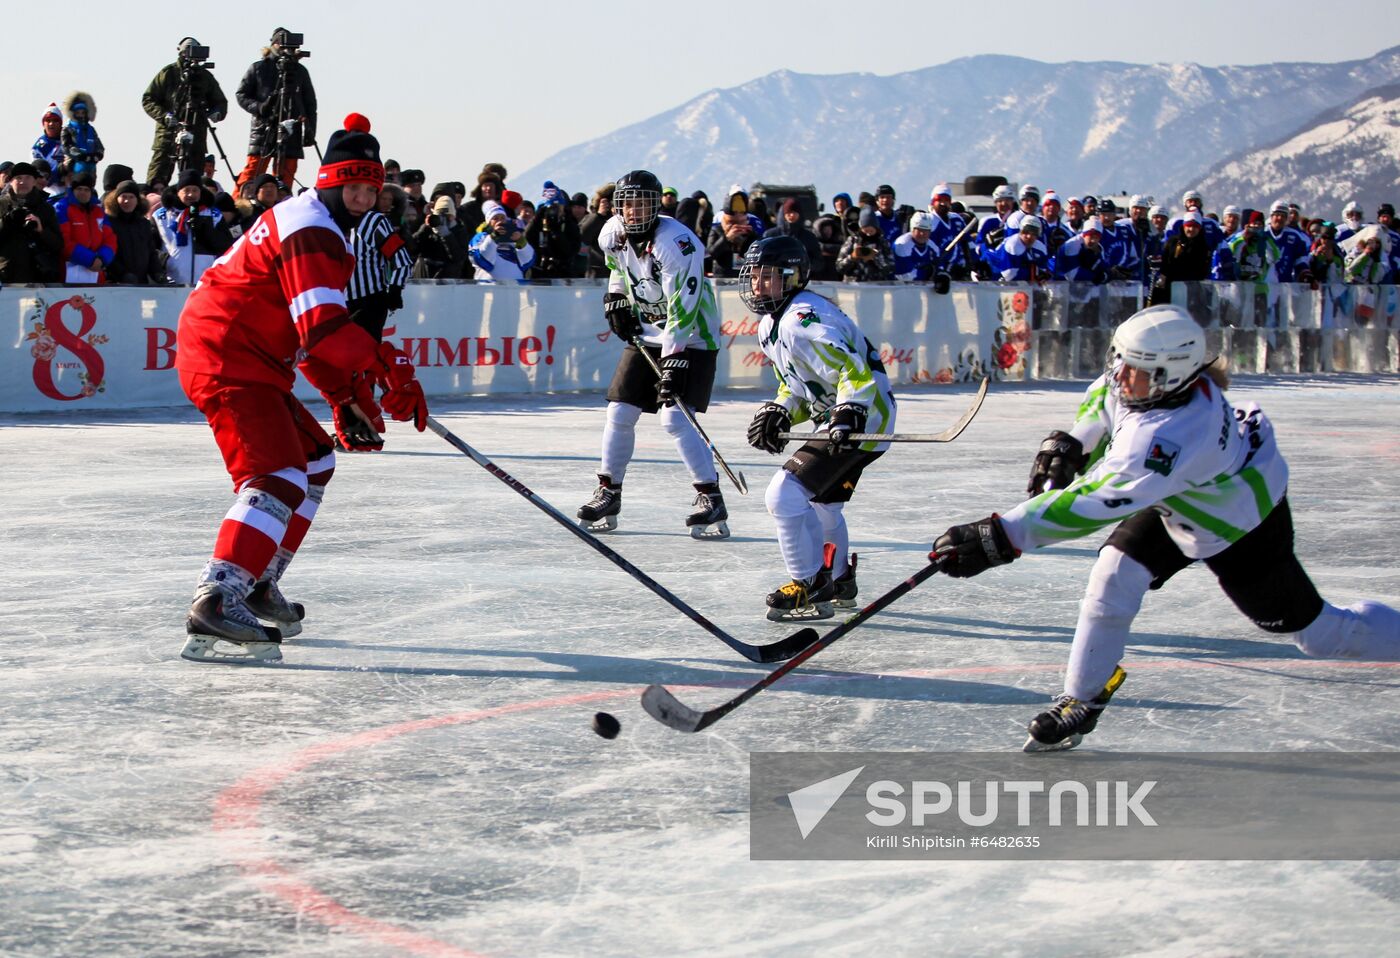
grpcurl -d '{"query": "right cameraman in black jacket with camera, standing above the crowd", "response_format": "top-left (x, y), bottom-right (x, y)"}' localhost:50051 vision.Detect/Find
top-left (234, 27), bottom-right (316, 193)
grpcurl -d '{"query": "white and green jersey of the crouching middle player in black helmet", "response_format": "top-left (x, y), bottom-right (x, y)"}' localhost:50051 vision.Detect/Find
top-left (759, 290), bottom-right (895, 452)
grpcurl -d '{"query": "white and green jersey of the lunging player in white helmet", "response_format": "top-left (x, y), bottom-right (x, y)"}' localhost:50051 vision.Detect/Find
top-left (1002, 375), bottom-right (1288, 559)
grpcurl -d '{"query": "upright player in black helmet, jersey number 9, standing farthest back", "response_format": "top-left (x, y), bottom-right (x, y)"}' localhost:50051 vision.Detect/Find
top-left (578, 169), bottom-right (729, 539)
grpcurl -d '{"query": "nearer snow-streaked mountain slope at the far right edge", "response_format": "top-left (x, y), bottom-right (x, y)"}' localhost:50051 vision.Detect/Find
top-left (1198, 84), bottom-right (1400, 215)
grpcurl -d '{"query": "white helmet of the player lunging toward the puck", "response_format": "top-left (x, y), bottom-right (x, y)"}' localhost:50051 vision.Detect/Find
top-left (1109, 305), bottom-right (1205, 409)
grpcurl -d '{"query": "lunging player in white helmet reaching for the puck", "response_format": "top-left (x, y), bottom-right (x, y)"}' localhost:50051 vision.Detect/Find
top-left (930, 305), bottom-right (1400, 751)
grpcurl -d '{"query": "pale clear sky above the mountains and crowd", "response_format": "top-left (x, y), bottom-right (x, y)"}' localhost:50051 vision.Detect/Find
top-left (8, 0), bottom-right (1400, 190)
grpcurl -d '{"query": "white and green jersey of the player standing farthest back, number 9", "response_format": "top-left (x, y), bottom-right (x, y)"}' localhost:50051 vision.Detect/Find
top-left (598, 216), bottom-right (720, 356)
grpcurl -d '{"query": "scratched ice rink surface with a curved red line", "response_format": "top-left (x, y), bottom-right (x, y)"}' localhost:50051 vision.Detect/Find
top-left (0, 377), bottom-right (1400, 958)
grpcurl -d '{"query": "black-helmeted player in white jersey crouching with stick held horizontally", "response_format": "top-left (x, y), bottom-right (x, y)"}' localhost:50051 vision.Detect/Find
top-left (739, 237), bottom-right (895, 622)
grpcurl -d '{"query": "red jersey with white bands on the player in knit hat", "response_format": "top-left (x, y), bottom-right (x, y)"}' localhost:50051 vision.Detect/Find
top-left (175, 190), bottom-right (377, 391)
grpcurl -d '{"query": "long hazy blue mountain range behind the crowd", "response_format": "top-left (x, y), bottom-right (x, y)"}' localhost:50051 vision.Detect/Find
top-left (511, 48), bottom-right (1400, 204)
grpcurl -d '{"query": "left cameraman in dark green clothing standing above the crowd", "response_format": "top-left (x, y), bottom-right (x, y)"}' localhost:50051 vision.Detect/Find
top-left (141, 36), bottom-right (228, 183)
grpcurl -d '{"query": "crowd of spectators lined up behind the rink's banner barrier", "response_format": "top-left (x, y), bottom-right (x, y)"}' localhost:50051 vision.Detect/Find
top-left (0, 28), bottom-right (1400, 303)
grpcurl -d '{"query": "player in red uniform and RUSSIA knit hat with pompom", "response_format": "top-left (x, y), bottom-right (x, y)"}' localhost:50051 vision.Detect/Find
top-left (175, 119), bottom-right (427, 662)
